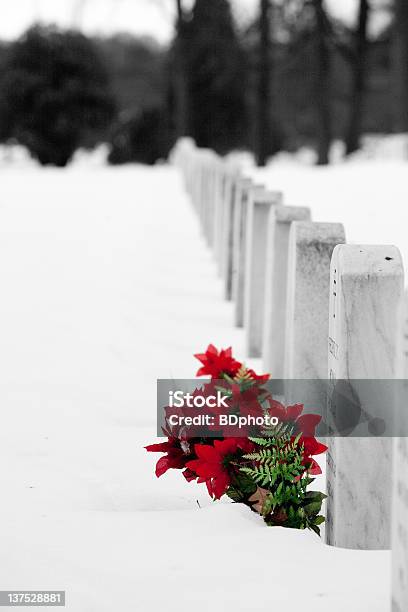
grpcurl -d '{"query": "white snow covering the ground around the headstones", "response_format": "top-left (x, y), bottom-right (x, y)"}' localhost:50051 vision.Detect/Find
top-left (0, 164), bottom-right (398, 612)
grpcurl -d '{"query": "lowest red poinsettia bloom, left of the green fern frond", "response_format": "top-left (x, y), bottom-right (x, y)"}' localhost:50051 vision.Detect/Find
top-left (187, 438), bottom-right (253, 499)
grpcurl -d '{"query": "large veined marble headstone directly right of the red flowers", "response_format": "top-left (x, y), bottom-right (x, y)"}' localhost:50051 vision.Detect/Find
top-left (326, 245), bottom-right (403, 550)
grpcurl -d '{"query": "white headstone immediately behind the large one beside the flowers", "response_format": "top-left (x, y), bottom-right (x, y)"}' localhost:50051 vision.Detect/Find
top-left (284, 221), bottom-right (345, 379)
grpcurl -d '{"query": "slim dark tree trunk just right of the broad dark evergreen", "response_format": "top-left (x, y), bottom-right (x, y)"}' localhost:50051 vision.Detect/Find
top-left (255, 0), bottom-right (272, 166)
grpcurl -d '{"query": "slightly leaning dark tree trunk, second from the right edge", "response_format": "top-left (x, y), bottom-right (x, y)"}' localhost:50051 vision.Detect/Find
top-left (346, 0), bottom-right (370, 155)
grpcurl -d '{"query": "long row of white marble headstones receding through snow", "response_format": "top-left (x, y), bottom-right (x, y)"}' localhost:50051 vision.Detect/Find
top-left (172, 139), bottom-right (408, 612)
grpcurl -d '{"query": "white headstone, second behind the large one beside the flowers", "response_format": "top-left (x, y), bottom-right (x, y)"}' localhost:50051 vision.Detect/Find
top-left (262, 206), bottom-right (310, 379)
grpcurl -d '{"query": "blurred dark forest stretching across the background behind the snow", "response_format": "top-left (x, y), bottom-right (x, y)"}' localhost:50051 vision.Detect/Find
top-left (0, 0), bottom-right (408, 166)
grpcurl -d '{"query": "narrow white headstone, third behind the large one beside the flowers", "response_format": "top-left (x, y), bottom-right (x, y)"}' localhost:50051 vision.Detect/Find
top-left (244, 190), bottom-right (282, 357)
